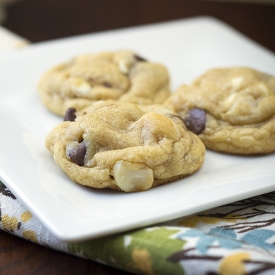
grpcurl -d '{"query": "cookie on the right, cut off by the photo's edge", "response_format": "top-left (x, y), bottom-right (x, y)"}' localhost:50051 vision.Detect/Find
top-left (165, 67), bottom-right (275, 154)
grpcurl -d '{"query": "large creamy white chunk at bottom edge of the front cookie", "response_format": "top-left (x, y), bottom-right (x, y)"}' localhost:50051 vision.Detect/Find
top-left (113, 161), bottom-right (154, 192)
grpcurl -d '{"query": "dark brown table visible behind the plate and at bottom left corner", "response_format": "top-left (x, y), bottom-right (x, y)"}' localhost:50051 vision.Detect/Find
top-left (0, 0), bottom-right (275, 275)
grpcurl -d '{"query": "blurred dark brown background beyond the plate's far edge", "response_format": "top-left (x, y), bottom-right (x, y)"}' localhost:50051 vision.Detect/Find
top-left (0, 0), bottom-right (275, 51)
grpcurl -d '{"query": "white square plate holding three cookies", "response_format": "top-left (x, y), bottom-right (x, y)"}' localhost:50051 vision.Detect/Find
top-left (0, 17), bottom-right (275, 241)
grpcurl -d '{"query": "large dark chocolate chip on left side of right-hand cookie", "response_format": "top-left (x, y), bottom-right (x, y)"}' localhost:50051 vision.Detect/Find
top-left (184, 108), bottom-right (206, 135)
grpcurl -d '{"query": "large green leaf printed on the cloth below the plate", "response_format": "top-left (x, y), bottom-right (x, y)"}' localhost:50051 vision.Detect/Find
top-left (68, 227), bottom-right (187, 275)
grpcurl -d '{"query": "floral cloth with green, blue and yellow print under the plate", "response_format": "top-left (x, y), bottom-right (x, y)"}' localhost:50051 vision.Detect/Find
top-left (0, 182), bottom-right (275, 275)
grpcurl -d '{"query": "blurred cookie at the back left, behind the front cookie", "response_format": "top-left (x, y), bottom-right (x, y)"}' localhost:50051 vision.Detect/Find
top-left (37, 51), bottom-right (170, 116)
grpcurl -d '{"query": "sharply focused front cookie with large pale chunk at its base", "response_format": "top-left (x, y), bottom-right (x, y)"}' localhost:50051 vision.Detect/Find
top-left (46, 101), bottom-right (205, 192)
